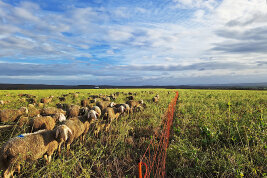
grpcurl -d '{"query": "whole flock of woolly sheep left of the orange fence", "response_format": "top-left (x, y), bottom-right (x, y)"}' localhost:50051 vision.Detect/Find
top-left (0, 92), bottom-right (159, 178)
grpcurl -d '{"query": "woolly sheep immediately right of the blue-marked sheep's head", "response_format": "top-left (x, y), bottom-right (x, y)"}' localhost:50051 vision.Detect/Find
top-left (59, 117), bottom-right (90, 153)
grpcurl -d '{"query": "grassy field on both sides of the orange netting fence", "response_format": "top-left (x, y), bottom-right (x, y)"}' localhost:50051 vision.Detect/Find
top-left (0, 89), bottom-right (267, 177)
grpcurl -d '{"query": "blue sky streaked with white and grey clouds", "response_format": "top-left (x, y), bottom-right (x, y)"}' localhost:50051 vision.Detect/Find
top-left (0, 0), bottom-right (267, 85)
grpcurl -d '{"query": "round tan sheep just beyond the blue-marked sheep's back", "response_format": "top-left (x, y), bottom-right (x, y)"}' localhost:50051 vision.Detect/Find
top-left (30, 116), bottom-right (56, 132)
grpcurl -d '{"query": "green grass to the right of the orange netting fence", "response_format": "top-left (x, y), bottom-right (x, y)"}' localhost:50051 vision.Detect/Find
top-left (166, 90), bottom-right (267, 177)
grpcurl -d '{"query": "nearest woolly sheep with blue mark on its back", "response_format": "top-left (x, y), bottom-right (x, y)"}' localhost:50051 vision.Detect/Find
top-left (0, 125), bottom-right (72, 178)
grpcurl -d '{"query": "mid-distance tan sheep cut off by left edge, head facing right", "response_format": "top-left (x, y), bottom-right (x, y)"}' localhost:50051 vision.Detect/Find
top-left (0, 107), bottom-right (28, 122)
